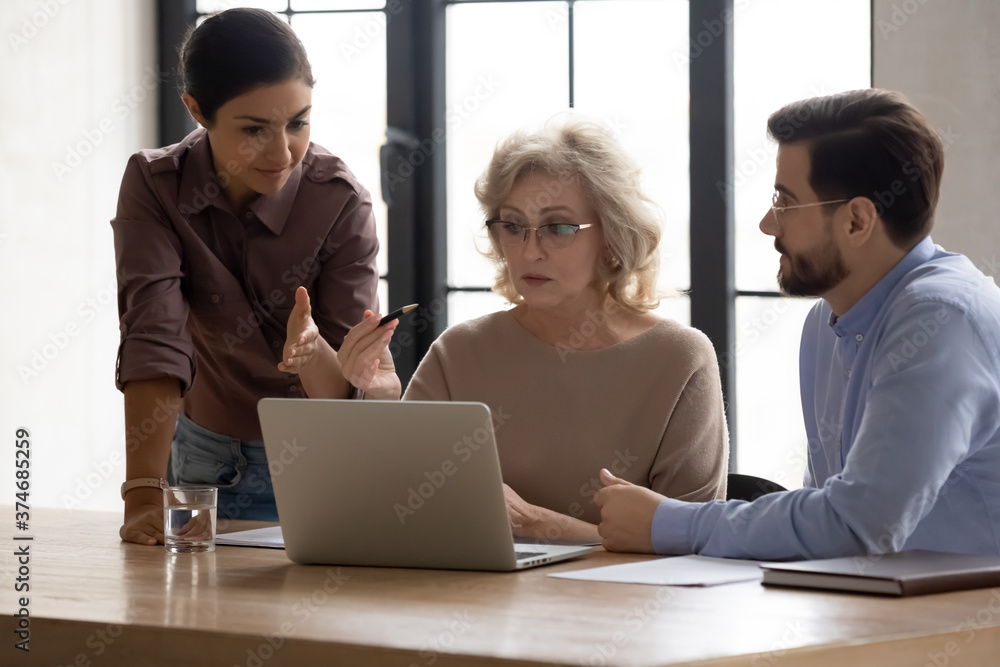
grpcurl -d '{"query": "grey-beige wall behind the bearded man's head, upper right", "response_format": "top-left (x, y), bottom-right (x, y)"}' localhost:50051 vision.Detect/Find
top-left (873, 0), bottom-right (1000, 266)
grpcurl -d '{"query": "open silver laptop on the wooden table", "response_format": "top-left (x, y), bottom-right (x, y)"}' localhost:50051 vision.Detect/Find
top-left (257, 398), bottom-right (591, 571)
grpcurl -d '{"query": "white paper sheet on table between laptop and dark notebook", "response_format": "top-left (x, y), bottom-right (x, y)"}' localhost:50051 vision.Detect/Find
top-left (549, 556), bottom-right (763, 586)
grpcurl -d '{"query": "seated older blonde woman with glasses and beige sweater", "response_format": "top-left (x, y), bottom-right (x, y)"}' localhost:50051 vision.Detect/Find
top-left (404, 119), bottom-right (728, 542)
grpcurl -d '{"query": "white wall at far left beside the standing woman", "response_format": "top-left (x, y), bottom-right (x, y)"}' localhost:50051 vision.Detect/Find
top-left (0, 0), bottom-right (157, 520)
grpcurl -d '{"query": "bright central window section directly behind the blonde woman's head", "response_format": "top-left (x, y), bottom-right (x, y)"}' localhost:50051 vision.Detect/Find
top-left (447, 0), bottom-right (690, 324)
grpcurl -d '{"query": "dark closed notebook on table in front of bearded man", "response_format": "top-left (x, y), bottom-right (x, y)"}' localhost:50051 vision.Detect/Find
top-left (761, 551), bottom-right (1000, 595)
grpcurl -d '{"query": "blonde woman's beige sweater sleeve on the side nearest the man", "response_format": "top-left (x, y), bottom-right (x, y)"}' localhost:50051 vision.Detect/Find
top-left (649, 335), bottom-right (729, 502)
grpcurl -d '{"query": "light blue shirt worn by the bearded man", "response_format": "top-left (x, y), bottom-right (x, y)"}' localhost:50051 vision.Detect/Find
top-left (652, 238), bottom-right (1000, 560)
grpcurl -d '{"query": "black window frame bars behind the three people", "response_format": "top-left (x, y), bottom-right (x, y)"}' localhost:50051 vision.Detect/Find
top-left (157, 0), bottom-right (875, 470)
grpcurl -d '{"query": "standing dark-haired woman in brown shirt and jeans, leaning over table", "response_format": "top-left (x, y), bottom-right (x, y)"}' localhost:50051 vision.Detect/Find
top-left (111, 9), bottom-right (400, 544)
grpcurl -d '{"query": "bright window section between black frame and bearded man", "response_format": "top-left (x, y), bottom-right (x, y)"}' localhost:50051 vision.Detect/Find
top-left (726, 0), bottom-right (871, 487)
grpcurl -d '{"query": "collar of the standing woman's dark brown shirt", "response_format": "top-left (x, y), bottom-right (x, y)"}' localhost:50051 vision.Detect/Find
top-left (178, 129), bottom-right (302, 234)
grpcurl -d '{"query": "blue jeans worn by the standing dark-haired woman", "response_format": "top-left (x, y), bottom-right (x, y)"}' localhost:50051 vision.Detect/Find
top-left (167, 414), bottom-right (278, 521)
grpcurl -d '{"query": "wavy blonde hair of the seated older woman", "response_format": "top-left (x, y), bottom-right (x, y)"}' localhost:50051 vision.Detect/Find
top-left (475, 116), bottom-right (662, 313)
